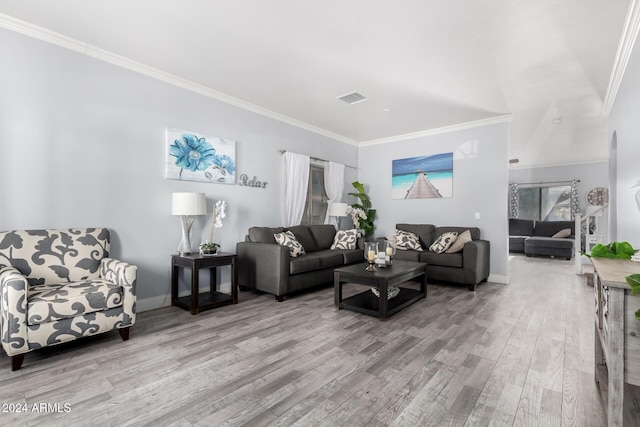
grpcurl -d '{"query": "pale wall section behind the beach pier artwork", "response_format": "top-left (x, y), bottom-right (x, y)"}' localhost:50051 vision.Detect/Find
top-left (359, 123), bottom-right (509, 283)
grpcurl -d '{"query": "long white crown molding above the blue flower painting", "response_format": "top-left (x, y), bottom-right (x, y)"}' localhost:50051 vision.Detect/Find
top-left (0, 13), bottom-right (358, 147)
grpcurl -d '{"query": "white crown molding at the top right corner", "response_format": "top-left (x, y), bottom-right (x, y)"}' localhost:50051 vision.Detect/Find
top-left (602, 0), bottom-right (640, 116)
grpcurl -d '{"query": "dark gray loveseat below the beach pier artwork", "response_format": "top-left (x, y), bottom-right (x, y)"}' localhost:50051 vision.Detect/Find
top-left (395, 224), bottom-right (491, 291)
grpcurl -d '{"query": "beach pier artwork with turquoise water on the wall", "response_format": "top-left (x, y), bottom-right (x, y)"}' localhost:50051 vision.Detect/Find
top-left (391, 153), bottom-right (453, 199)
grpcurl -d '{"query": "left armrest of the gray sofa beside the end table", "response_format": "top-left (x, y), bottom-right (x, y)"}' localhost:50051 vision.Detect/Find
top-left (236, 242), bottom-right (290, 296)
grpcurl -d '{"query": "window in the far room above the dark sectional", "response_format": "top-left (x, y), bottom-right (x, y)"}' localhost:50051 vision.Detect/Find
top-left (518, 185), bottom-right (571, 221)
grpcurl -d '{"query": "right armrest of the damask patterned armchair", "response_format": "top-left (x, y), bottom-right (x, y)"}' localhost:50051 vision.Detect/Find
top-left (100, 258), bottom-right (138, 328)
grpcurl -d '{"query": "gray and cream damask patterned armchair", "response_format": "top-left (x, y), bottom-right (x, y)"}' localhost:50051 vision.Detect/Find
top-left (0, 228), bottom-right (137, 371)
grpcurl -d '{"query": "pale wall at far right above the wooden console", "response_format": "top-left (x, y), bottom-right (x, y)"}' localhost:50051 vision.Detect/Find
top-left (609, 33), bottom-right (640, 248)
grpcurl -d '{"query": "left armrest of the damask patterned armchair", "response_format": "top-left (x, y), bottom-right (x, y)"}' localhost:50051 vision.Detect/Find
top-left (0, 265), bottom-right (29, 356)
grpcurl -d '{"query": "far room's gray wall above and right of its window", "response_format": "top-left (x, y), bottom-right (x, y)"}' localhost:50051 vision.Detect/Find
top-left (509, 162), bottom-right (609, 213)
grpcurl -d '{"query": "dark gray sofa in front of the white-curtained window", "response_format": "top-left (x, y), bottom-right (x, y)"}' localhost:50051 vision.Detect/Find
top-left (236, 225), bottom-right (364, 302)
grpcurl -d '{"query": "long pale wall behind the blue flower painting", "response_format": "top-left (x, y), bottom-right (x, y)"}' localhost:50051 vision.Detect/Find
top-left (0, 30), bottom-right (358, 308)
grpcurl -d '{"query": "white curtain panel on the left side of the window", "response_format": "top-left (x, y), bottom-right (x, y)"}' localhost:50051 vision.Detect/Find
top-left (284, 151), bottom-right (309, 227)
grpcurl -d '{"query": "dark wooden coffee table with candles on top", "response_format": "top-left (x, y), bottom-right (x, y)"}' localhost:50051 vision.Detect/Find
top-left (333, 260), bottom-right (427, 320)
